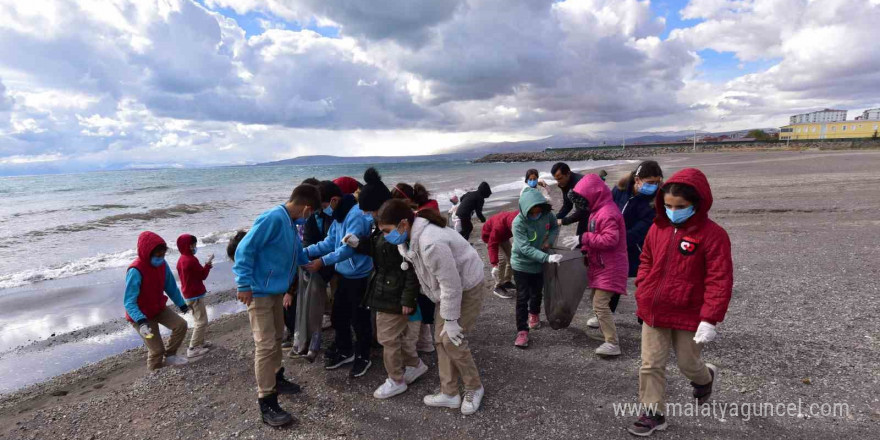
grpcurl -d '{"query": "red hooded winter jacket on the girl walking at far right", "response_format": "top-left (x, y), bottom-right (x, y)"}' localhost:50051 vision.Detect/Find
top-left (636, 168), bottom-right (733, 331)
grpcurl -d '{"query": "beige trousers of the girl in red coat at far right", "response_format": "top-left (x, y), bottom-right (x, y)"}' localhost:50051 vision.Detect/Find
top-left (640, 324), bottom-right (712, 414)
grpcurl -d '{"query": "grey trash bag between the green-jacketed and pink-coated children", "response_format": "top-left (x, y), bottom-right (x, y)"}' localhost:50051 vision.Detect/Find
top-left (544, 248), bottom-right (589, 330)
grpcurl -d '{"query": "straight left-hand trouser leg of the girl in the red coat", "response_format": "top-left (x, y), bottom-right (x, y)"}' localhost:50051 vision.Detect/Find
top-left (639, 324), bottom-right (672, 414)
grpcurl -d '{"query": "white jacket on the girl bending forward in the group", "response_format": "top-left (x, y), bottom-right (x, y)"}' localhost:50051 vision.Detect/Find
top-left (401, 217), bottom-right (483, 319)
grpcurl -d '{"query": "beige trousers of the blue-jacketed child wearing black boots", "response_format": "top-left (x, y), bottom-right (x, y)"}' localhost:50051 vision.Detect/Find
top-left (248, 295), bottom-right (284, 398)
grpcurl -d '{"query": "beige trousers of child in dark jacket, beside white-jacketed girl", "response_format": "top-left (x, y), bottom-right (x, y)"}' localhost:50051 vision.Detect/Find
top-left (376, 312), bottom-right (422, 382)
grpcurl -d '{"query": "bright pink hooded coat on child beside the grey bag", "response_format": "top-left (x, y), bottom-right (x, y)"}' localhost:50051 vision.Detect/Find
top-left (574, 174), bottom-right (629, 295)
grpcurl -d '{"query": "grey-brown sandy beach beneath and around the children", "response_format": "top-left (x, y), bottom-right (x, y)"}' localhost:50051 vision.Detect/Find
top-left (0, 151), bottom-right (880, 440)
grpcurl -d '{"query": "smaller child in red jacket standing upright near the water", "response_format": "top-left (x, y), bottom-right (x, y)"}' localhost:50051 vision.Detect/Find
top-left (177, 234), bottom-right (214, 358)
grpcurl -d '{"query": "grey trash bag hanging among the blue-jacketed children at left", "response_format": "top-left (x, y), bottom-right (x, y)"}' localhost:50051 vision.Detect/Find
top-left (293, 268), bottom-right (327, 353)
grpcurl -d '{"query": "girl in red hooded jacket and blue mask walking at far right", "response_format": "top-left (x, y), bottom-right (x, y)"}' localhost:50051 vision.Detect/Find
top-left (629, 168), bottom-right (733, 436)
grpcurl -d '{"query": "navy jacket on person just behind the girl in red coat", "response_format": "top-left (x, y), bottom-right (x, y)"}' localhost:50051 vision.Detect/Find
top-left (611, 177), bottom-right (654, 277)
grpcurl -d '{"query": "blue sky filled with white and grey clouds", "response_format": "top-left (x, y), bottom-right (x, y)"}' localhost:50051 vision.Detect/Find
top-left (0, 0), bottom-right (880, 174)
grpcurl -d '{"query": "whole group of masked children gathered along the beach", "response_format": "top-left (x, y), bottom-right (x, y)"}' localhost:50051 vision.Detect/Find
top-left (125, 161), bottom-right (733, 436)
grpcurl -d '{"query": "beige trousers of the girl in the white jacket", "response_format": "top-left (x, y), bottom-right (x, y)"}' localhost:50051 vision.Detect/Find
top-left (434, 284), bottom-right (483, 396)
